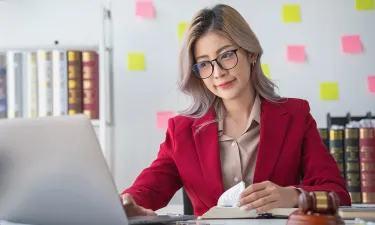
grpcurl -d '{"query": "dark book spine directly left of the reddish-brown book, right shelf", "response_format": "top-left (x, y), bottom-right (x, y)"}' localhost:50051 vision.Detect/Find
top-left (344, 128), bottom-right (362, 204)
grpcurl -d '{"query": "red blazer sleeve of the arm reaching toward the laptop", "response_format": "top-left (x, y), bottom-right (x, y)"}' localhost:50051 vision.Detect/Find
top-left (121, 119), bottom-right (182, 211)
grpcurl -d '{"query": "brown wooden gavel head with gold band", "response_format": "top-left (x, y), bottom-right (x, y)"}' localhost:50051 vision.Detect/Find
top-left (298, 191), bottom-right (340, 215)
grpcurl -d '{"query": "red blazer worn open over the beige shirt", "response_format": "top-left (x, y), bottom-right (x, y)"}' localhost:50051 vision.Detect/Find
top-left (123, 98), bottom-right (351, 216)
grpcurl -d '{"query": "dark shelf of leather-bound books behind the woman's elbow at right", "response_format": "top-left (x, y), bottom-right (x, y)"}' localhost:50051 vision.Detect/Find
top-left (319, 111), bottom-right (375, 207)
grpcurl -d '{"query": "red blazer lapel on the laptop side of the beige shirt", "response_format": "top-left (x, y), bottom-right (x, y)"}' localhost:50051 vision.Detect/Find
top-left (192, 108), bottom-right (224, 201)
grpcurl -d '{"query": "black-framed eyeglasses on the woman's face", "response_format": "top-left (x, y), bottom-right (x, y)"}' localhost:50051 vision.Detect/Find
top-left (191, 48), bottom-right (240, 79)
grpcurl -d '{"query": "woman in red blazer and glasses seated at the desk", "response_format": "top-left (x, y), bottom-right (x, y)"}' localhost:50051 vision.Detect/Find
top-left (122, 5), bottom-right (351, 216)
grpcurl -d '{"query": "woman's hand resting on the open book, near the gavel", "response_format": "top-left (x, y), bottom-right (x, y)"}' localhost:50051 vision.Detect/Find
top-left (238, 181), bottom-right (300, 213)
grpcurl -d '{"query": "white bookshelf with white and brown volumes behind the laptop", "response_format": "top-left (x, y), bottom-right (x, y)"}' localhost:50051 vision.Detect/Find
top-left (0, 4), bottom-right (113, 171)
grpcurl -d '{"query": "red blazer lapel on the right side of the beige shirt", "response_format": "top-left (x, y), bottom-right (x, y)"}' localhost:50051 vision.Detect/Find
top-left (254, 98), bottom-right (290, 183)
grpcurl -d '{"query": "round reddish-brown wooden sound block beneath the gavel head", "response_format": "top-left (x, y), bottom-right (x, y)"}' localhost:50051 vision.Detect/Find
top-left (287, 209), bottom-right (345, 225)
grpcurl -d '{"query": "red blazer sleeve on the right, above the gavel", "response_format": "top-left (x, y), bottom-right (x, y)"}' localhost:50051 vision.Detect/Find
top-left (295, 101), bottom-right (351, 205)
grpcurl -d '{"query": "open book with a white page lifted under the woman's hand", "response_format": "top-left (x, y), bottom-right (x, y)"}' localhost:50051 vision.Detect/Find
top-left (199, 181), bottom-right (297, 219)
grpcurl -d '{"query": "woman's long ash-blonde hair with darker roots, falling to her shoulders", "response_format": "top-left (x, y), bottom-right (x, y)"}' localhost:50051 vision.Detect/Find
top-left (178, 4), bottom-right (282, 118)
